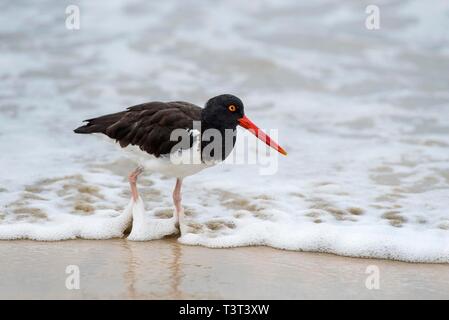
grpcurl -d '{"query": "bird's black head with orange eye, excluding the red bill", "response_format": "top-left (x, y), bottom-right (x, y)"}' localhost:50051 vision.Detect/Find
top-left (201, 94), bottom-right (245, 130)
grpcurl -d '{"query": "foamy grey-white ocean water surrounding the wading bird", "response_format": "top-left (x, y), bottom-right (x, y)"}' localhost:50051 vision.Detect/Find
top-left (0, 0), bottom-right (449, 263)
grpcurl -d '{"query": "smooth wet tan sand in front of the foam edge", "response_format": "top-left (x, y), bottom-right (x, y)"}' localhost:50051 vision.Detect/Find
top-left (0, 238), bottom-right (449, 299)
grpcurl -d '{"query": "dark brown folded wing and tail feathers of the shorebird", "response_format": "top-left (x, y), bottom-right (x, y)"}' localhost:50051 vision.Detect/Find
top-left (75, 101), bottom-right (202, 157)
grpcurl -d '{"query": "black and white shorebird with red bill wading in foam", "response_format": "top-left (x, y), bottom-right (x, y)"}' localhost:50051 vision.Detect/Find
top-left (74, 94), bottom-right (287, 230)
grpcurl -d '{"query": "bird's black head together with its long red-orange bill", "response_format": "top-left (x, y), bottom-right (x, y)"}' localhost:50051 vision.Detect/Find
top-left (202, 94), bottom-right (287, 155)
